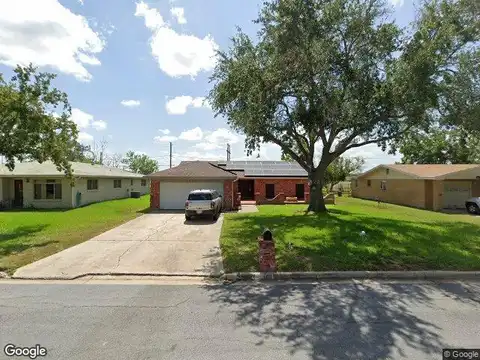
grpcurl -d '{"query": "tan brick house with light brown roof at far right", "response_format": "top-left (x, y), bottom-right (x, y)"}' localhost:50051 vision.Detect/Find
top-left (351, 164), bottom-right (480, 211)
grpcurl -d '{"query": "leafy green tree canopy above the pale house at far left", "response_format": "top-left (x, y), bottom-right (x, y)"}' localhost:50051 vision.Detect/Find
top-left (0, 65), bottom-right (78, 175)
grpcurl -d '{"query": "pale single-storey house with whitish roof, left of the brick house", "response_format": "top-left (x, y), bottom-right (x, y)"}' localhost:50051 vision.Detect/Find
top-left (0, 161), bottom-right (149, 209)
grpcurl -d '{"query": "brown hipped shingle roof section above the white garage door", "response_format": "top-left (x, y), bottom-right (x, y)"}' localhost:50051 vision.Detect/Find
top-left (147, 161), bottom-right (237, 180)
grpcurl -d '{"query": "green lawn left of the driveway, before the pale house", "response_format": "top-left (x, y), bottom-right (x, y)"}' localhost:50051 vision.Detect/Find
top-left (0, 195), bottom-right (149, 274)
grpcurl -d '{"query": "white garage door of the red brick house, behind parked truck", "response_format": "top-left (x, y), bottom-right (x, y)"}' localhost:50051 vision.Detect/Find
top-left (160, 181), bottom-right (223, 210)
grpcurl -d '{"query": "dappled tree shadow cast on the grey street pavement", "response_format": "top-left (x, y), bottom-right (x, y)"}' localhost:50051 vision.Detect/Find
top-left (201, 282), bottom-right (478, 360)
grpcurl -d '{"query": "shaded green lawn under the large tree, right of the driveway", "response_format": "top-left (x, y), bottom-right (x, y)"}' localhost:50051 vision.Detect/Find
top-left (221, 197), bottom-right (480, 272)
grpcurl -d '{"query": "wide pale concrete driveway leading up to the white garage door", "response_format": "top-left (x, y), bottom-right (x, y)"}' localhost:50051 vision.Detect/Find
top-left (13, 213), bottom-right (223, 279)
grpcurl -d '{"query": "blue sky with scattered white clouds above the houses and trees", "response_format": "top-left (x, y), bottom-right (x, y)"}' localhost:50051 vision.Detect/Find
top-left (0, 0), bottom-right (413, 168)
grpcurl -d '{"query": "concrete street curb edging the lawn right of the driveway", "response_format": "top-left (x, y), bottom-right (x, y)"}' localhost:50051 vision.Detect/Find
top-left (223, 270), bottom-right (480, 281)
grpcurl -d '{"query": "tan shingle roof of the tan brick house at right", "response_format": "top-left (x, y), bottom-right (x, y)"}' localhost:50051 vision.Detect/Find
top-left (358, 164), bottom-right (480, 179)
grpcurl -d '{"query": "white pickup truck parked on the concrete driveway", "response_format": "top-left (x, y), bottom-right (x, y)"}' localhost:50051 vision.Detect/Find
top-left (185, 189), bottom-right (223, 220)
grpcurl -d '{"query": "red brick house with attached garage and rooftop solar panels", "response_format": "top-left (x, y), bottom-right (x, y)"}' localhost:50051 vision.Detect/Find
top-left (146, 161), bottom-right (310, 210)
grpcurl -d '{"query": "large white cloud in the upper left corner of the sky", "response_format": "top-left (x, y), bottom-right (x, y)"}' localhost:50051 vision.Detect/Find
top-left (0, 0), bottom-right (105, 81)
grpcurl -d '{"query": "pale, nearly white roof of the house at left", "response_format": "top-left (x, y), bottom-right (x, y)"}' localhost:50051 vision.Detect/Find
top-left (0, 161), bottom-right (143, 178)
